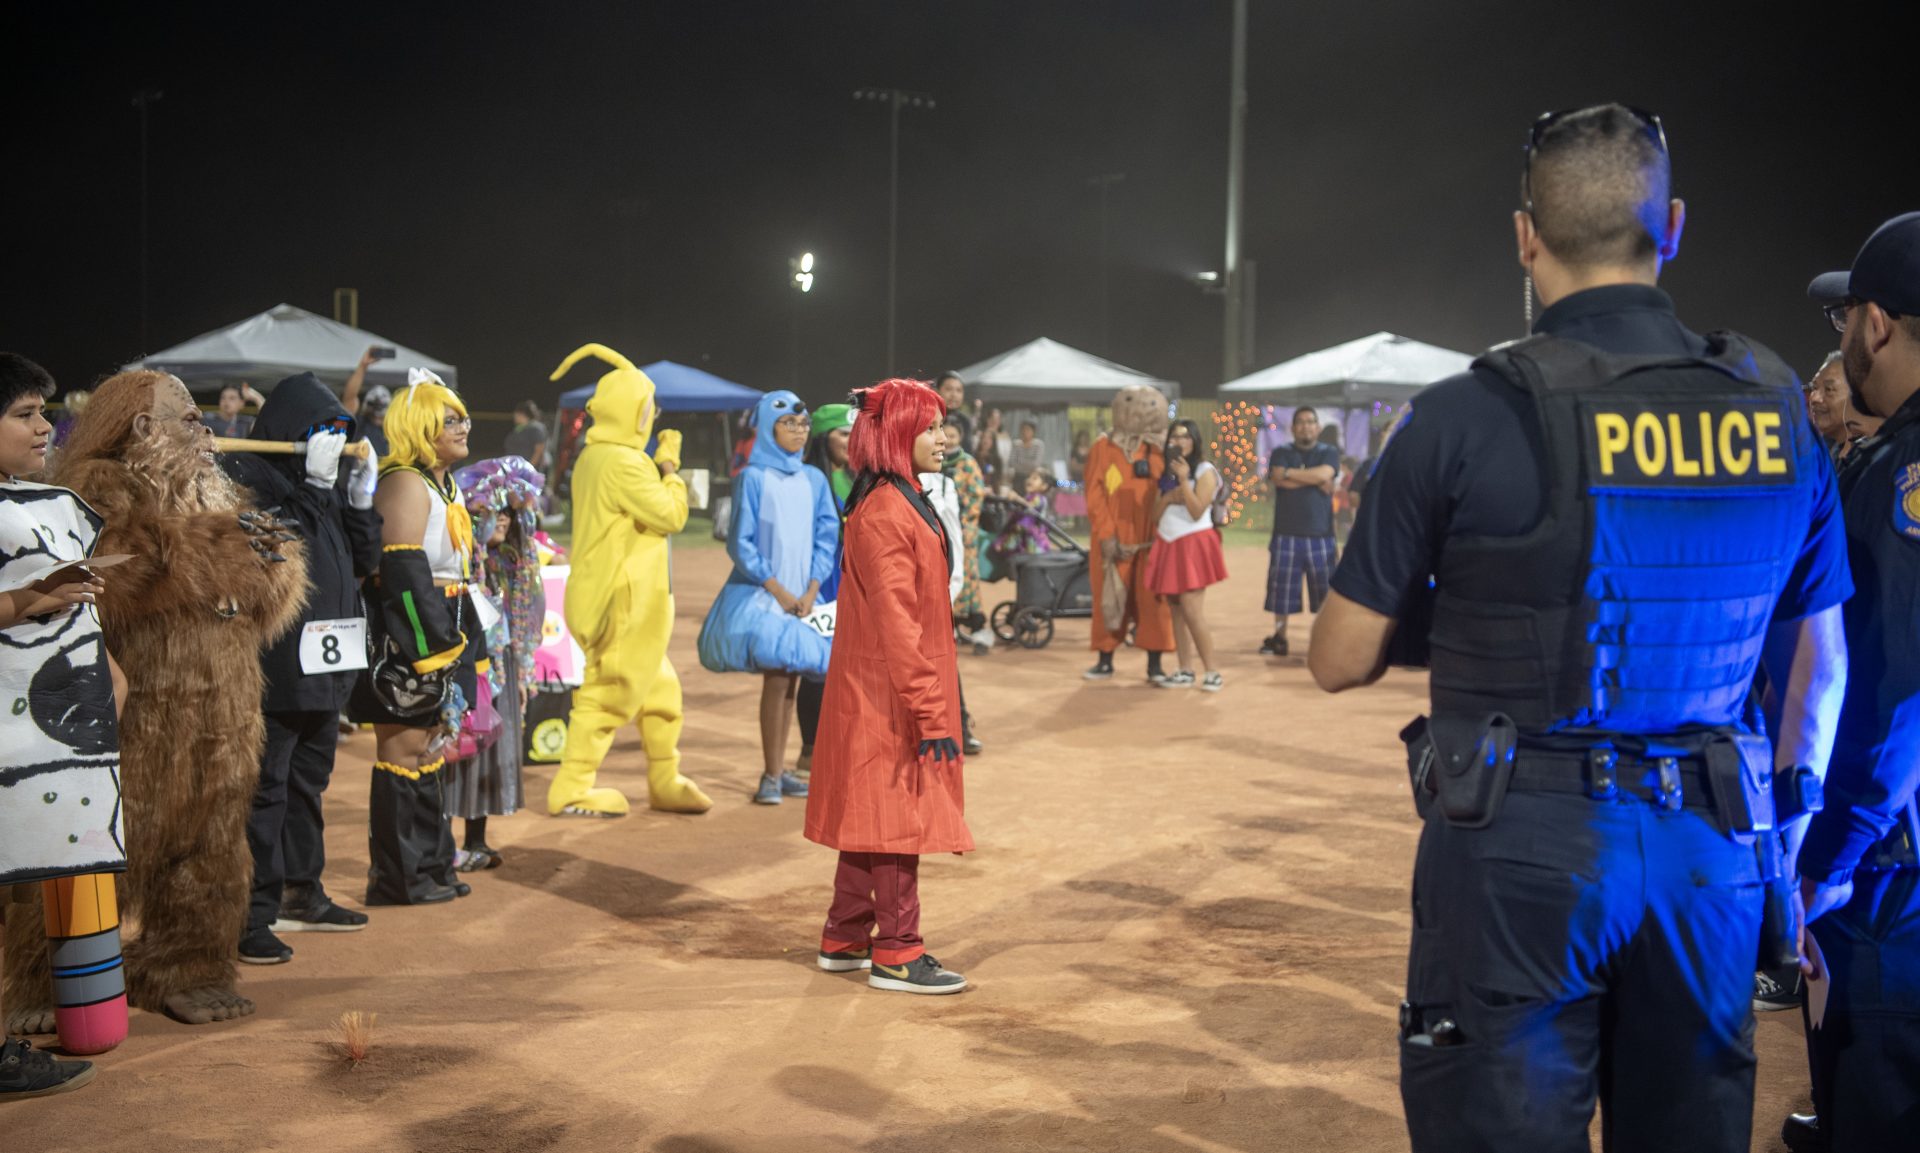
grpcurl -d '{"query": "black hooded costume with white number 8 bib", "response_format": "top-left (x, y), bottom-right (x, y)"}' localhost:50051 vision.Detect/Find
top-left (221, 372), bottom-right (380, 932)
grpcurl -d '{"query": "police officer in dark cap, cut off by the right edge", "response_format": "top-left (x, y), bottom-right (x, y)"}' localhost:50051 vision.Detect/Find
top-left (1799, 213), bottom-right (1920, 1151)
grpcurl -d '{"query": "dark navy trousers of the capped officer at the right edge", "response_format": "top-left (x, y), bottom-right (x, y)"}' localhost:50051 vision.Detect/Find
top-left (1807, 869), bottom-right (1920, 1153)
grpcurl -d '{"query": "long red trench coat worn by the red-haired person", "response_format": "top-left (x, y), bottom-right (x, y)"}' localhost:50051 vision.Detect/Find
top-left (806, 475), bottom-right (973, 854)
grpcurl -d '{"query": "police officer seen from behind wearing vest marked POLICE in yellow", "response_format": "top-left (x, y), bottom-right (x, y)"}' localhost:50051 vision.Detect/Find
top-left (1309, 104), bottom-right (1851, 1153)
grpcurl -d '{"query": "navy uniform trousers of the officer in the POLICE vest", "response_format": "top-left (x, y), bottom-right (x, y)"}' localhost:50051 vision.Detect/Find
top-left (1400, 790), bottom-right (1764, 1153)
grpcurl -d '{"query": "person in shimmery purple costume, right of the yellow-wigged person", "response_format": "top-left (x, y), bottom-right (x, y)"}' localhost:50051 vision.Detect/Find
top-left (447, 457), bottom-right (547, 859)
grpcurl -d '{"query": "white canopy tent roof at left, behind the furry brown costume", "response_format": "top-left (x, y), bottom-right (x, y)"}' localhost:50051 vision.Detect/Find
top-left (127, 305), bottom-right (459, 393)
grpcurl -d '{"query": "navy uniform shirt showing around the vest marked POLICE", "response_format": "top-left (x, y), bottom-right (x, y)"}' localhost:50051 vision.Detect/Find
top-left (1332, 284), bottom-right (1853, 633)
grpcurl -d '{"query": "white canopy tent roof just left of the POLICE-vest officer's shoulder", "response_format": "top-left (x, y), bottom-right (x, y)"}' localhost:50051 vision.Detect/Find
top-left (1219, 332), bottom-right (1473, 407)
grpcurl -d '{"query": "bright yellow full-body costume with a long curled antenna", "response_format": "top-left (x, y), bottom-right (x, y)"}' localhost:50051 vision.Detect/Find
top-left (547, 343), bottom-right (714, 817)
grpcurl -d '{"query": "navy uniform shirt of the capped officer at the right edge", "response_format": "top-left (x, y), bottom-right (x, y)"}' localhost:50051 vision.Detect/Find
top-left (1799, 393), bottom-right (1920, 884)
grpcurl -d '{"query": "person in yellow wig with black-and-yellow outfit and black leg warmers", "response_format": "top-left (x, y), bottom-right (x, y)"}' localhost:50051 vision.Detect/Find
top-left (351, 368), bottom-right (480, 906)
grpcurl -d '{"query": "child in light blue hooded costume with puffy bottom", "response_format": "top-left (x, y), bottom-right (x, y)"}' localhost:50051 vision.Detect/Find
top-left (699, 391), bottom-right (839, 804)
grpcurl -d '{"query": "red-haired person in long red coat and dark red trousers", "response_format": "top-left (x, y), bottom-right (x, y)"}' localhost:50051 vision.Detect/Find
top-left (806, 380), bottom-right (973, 994)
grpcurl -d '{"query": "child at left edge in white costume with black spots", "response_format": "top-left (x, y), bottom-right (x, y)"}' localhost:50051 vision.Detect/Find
top-left (0, 353), bottom-right (127, 1101)
